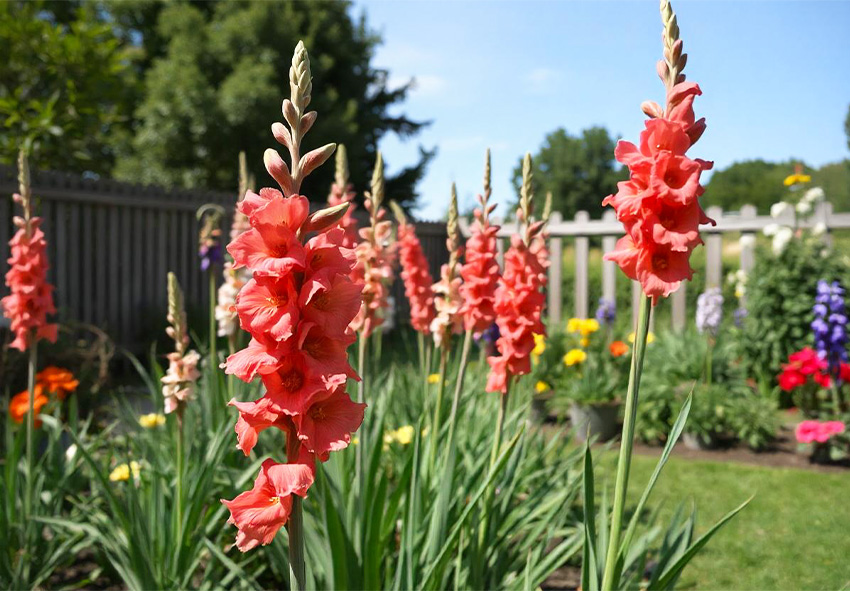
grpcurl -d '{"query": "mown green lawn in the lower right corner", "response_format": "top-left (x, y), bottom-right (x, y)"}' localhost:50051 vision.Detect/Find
top-left (616, 452), bottom-right (850, 590)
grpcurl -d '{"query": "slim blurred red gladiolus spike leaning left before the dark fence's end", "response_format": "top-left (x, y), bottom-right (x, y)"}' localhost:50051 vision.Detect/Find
top-left (398, 217), bottom-right (435, 335)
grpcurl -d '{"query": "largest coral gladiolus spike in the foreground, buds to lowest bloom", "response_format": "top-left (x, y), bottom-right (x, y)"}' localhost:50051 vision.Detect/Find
top-left (222, 42), bottom-right (364, 560)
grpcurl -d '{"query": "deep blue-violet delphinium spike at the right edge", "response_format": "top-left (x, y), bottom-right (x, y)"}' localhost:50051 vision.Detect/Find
top-left (812, 279), bottom-right (847, 380)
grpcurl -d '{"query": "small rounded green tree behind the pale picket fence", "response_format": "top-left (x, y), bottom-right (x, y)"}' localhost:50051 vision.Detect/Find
top-left (513, 127), bottom-right (628, 218)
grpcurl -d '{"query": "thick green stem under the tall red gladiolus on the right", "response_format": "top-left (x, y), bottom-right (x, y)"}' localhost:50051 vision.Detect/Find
top-left (602, 297), bottom-right (652, 591)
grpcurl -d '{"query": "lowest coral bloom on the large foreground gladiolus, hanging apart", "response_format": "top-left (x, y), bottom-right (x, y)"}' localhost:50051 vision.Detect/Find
top-left (222, 459), bottom-right (315, 552)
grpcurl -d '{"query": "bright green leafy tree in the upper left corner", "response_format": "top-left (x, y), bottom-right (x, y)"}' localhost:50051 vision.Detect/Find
top-left (0, 0), bottom-right (134, 173)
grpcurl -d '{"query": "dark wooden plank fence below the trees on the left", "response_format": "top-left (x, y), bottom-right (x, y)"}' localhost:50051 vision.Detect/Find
top-left (0, 166), bottom-right (448, 351)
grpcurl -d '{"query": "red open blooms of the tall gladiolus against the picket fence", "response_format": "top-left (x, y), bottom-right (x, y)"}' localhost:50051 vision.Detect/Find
top-left (602, 63), bottom-right (714, 305)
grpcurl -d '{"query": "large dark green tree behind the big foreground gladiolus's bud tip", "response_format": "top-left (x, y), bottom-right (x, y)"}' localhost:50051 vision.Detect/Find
top-left (112, 2), bottom-right (433, 205)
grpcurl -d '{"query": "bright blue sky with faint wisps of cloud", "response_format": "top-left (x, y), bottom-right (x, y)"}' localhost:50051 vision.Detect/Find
top-left (353, 0), bottom-right (850, 219)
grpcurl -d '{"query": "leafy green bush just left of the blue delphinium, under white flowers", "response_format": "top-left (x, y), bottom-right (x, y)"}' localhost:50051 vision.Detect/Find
top-left (740, 237), bottom-right (848, 383)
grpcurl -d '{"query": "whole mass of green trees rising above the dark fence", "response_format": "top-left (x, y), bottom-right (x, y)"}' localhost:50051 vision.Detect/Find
top-left (0, 0), bottom-right (434, 206)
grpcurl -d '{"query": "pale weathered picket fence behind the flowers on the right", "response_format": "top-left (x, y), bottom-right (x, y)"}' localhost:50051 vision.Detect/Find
top-left (460, 202), bottom-right (850, 330)
